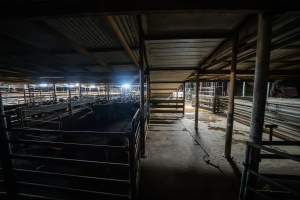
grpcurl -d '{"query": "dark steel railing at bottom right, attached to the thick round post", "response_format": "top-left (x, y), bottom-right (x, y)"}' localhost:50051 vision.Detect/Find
top-left (240, 141), bottom-right (300, 200)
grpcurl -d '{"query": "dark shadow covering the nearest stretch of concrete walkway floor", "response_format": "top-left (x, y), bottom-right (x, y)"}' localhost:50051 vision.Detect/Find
top-left (140, 164), bottom-right (239, 200)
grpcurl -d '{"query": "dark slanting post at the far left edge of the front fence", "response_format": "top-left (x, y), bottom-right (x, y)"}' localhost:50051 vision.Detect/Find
top-left (0, 93), bottom-right (17, 199)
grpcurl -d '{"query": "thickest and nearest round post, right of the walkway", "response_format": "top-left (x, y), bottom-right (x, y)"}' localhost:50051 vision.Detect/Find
top-left (244, 13), bottom-right (272, 199)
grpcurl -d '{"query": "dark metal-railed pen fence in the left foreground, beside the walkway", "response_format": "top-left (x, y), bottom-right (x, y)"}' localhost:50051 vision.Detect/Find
top-left (0, 105), bottom-right (147, 199)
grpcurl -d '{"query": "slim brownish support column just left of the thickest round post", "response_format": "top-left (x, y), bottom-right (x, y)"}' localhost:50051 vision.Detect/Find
top-left (225, 35), bottom-right (238, 159)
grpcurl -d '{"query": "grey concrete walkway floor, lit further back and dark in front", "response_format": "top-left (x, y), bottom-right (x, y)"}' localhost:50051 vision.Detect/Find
top-left (140, 105), bottom-right (299, 200)
